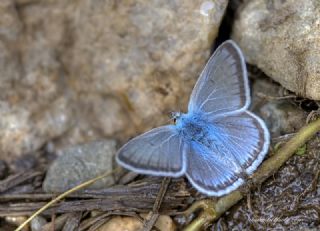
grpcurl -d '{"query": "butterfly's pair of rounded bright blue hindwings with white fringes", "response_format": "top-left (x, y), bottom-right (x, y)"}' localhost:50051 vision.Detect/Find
top-left (186, 111), bottom-right (270, 196)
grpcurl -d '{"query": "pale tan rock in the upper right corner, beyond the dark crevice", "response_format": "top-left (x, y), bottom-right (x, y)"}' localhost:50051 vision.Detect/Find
top-left (232, 0), bottom-right (320, 100)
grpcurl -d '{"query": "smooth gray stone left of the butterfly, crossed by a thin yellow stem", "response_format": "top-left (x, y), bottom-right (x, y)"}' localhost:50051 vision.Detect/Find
top-left (43, 140), bottom-right (116, 192)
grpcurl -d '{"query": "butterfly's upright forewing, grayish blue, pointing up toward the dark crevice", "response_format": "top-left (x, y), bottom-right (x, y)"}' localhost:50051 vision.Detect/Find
top-left (188, 40), bottom-right (250, 115)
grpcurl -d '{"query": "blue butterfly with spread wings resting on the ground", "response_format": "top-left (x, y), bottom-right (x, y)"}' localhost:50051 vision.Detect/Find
top-left (116, 40), bottom-right (270, 196)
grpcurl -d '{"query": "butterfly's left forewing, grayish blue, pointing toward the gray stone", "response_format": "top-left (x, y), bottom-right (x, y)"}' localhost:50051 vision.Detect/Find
top-left (116, 125), bottom-right (185, 177)
